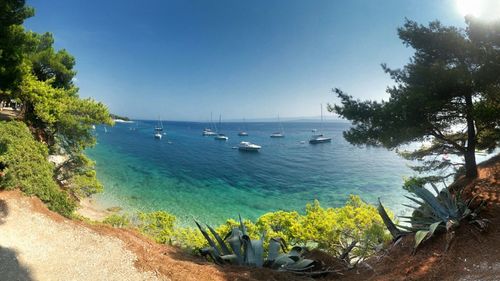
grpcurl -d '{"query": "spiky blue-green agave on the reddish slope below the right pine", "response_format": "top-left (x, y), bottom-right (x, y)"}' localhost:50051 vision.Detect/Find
top-left (378, 183), bottom-right (488, 251)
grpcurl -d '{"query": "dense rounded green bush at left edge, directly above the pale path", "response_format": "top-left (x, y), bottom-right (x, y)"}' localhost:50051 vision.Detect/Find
top-left (0, 121), bottom-right (75, 216)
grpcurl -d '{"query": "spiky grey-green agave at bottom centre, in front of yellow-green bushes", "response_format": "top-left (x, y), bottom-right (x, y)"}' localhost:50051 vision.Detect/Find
top-left (195, 216), bottom-right (333, 276)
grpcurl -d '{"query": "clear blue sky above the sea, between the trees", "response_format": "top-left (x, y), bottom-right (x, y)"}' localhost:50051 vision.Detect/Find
top-left (25, 0), bottom-right (480, 121)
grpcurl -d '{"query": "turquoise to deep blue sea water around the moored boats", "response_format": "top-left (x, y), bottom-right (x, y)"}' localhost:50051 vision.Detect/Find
top-left (86, 121), bottom-right (413, 224)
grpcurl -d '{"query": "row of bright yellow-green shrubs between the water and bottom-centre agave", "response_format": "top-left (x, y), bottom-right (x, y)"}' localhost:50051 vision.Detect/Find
top-left (130, 196), bottom-right (391, 261)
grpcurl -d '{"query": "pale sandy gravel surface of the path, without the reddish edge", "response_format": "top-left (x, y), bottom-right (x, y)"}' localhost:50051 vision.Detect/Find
top-left (0, 192), bottom-right (164, 281)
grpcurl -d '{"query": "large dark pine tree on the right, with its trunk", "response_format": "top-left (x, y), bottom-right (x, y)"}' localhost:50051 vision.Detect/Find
top-left (329, 18), bottom-right (500, 177)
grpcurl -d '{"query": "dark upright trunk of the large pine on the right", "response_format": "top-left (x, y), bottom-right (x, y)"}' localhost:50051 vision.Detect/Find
top-left (464, 95), bottom-right (477, 178)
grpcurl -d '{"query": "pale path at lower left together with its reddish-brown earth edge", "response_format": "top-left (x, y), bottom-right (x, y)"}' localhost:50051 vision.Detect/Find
top-left (0, 191), bottom-right (304, 281)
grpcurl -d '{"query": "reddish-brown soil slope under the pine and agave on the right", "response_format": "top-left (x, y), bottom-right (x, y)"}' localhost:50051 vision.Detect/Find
top-left (334, 156), bottom-right (500, 281)
